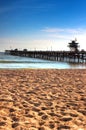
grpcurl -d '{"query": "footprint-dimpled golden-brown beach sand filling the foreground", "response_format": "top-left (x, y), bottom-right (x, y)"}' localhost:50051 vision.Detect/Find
top-left (0, 70), bottom-right (86, 130)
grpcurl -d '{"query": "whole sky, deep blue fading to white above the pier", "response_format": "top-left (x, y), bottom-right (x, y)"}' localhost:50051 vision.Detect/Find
top-left (0, 0), bottom-right (86, 51)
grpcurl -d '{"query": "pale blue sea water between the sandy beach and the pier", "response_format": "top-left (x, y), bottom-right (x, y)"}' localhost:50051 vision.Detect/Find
top-left (0, 52), bottom-right (86, 69)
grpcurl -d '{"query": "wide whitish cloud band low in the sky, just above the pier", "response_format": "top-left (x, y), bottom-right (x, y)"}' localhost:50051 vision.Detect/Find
top-left (0, 28), bottom-right (86, 50)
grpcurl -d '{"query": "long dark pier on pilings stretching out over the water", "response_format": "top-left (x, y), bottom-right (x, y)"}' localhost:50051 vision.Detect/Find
top-left (5, 50), bottom-right (86, 63)
